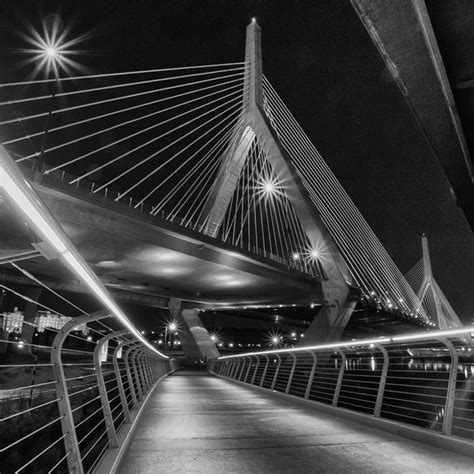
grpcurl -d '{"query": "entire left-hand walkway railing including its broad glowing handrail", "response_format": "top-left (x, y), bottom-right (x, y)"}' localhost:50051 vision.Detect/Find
top-left (0, 142), bottom-right (179, 473)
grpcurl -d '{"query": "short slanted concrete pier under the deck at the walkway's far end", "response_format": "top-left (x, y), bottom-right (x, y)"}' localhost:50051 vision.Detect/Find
top-left (168, 298), bottom-right (220, 360)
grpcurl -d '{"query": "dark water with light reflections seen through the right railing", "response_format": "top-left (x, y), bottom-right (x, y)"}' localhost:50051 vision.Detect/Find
top-left (334, 350), bottom-right (474, 439)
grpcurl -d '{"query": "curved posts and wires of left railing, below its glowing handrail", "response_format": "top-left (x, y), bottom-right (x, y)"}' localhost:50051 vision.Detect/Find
top-left (0, 313), bottom-right (175, 473)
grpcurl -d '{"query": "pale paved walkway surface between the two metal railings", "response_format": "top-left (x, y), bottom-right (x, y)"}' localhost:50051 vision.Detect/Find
top-left (120, 371), bottom-right (473, 474)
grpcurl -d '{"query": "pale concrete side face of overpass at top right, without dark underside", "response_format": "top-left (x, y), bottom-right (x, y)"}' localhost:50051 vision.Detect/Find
top-left (351, 0), bottom-right (474, 230)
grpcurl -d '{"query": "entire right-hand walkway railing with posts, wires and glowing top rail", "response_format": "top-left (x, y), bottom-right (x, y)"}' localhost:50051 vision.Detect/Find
top-left (211, 328), bottom-right (474, 440)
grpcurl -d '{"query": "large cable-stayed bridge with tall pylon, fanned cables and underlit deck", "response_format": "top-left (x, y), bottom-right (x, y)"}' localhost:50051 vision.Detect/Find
top-left (1, 22), bottom-right (446, 340)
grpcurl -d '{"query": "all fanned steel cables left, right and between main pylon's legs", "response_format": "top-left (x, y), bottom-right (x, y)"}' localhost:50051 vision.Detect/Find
top-left (0, 63), bottom-right (433, 325)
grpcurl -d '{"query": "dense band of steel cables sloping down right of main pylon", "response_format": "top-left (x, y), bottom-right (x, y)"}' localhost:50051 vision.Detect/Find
top-left (263, 77), bottom-right (430, 323)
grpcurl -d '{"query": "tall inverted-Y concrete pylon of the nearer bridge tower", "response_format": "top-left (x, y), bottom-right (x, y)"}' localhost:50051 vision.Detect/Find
top-left (198, 20), bottom-right (356, 343)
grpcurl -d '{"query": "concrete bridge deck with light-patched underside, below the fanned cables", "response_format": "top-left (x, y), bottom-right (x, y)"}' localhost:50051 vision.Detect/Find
top-left (0, 167), bottom-right (323, 308)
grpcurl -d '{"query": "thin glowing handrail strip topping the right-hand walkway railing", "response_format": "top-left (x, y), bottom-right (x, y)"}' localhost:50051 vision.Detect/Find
top-left (218, 326), bottom-right (474, 360)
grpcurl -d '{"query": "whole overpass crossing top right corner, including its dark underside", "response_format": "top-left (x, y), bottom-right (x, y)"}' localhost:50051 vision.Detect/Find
top-left (352, 0), bottom-right (474, 229)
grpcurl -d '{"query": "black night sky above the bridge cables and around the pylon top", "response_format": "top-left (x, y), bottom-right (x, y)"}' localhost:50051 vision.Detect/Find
top-left (0, 0), bottom-right (474, 322)
